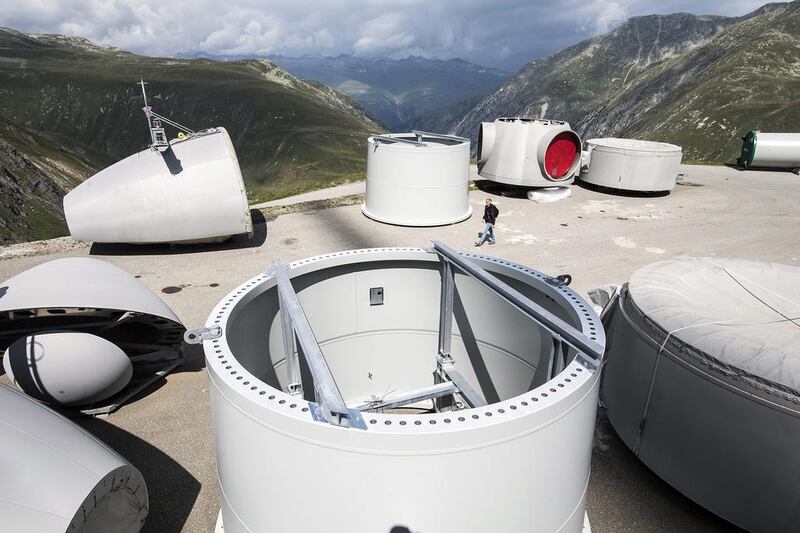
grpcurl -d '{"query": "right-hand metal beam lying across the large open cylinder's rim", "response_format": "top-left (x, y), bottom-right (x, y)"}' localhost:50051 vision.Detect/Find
top-left (433, 241), bottom-right (603, 369)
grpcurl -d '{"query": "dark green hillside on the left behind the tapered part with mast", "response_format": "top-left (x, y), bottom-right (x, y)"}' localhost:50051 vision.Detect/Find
top-left (0, 28), bottom-right (381, 242)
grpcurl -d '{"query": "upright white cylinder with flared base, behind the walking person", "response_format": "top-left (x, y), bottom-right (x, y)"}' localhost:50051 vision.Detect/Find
top-left (361, 133), bottom-right (472, 226)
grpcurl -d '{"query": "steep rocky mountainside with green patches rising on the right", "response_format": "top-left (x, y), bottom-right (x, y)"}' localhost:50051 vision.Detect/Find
top-left (448, 2), bottom-right (800, 162)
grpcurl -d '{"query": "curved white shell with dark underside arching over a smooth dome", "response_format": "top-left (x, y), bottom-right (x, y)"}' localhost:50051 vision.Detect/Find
top-left (0, 257), bottom-right (186, 356)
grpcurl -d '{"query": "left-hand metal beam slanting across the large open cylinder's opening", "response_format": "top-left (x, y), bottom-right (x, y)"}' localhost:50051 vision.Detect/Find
top-left (275, 261), bottom-right (367, 429)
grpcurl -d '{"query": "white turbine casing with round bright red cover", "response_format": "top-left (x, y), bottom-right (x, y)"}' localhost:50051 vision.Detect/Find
top-left (478, 118), bottom-right (581, 187)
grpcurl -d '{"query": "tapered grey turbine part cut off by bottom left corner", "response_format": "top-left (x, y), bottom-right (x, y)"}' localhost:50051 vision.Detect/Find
top-left (0, 385), bottom-right (148, 533)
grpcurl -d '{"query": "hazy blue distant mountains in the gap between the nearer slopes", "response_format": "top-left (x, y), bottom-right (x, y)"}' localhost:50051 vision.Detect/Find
top-left (270, 55), bottom-right (508, 131)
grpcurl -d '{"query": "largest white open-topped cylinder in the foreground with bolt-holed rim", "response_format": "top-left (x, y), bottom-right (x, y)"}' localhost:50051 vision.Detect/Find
top-left (202, 248), bottom-right (605, 533)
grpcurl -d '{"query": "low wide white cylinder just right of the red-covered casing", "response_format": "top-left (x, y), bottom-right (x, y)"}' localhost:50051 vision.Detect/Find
top-left (580, 138), bottom-right (682, 192)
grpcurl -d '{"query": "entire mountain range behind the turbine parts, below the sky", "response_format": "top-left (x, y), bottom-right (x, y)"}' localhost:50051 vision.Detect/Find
top-left (0, 0), bottom-right (800, 242)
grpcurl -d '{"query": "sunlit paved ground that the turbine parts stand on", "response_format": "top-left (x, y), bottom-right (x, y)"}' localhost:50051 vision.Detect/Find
top-left (0, 166), bottom-right (800, 533)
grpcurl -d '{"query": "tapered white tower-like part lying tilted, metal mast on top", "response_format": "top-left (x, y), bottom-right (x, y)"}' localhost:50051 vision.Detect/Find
top-left (64, 128), bottom-right (252, 244)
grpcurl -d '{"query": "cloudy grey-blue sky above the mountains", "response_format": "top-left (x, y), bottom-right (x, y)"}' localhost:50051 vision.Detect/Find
top-left (0, 0), bottom-right (766, 70)
